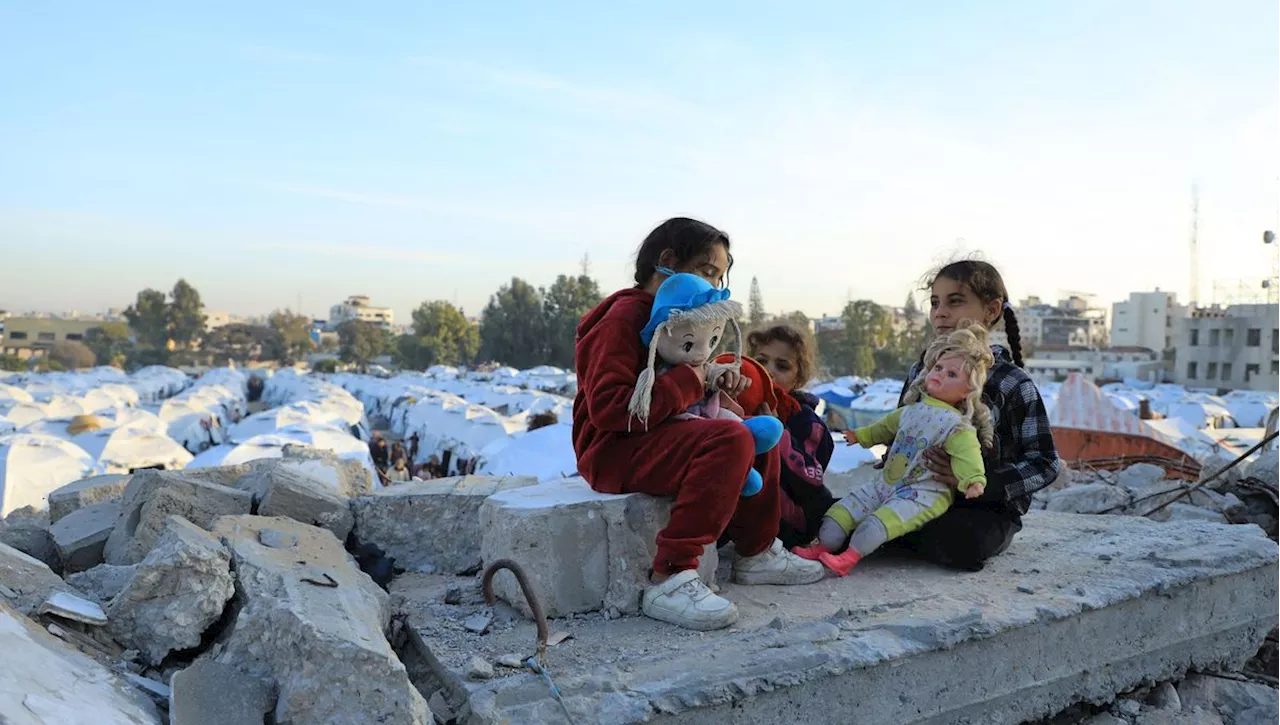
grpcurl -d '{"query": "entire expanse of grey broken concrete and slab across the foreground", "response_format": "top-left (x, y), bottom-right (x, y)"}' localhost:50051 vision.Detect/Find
top-left (0, 435), bottom-right (1280, 725)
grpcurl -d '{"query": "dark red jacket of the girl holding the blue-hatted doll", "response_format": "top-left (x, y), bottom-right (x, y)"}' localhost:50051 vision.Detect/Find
top-left (573, 288), bottom-right (703, 493)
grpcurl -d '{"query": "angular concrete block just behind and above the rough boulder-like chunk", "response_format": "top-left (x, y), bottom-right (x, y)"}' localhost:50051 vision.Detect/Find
top-left (104, 470), bottom-right (253, 565)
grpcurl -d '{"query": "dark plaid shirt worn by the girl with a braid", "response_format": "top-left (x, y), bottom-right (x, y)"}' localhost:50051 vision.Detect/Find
top-left (897, 345), bottom-right (1062, 515)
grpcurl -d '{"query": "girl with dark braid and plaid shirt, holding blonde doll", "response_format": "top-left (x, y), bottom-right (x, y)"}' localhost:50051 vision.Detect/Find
top-left (899, 260), bottom-right (1062, 571)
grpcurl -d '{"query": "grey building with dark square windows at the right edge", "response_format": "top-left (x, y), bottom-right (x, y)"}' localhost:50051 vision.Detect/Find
top-left (1174, 305), bottom-right (1280, 391)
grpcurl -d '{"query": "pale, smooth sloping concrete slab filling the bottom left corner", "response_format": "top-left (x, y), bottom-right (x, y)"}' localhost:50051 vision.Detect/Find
top-left (0, 598), bottom-right (163, 725)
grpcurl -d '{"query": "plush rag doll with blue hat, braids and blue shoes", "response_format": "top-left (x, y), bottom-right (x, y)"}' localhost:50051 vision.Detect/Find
top-left (628, 273), bottom-right (782, 496)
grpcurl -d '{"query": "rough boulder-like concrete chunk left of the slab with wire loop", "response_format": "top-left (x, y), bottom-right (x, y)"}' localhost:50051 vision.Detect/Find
top-left (106, 516), bottom-right (236, 665)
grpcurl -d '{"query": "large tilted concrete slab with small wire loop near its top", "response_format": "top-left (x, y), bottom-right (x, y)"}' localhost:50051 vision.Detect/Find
top-left (214, 516), bottom-right (431, 725)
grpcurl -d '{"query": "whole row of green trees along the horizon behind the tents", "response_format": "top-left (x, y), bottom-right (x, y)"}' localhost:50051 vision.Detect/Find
top-left (0, 270), bottom-right (925, 377)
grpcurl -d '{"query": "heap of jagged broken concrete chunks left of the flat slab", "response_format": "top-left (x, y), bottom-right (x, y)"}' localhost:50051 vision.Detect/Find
top-left (0, 448), bottom-right (435, 725)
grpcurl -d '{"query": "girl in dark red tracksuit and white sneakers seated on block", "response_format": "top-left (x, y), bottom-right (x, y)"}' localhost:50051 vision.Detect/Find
top-left (573, 218), bottom-right (823, 630)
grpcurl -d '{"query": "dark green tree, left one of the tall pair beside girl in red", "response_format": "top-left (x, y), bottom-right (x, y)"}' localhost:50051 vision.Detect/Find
top-left (480, 277), bottom-right (547, 368)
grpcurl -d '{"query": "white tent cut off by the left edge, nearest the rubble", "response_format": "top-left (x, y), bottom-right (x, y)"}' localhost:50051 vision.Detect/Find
top-left (0, 433), bottom-right (96, 516)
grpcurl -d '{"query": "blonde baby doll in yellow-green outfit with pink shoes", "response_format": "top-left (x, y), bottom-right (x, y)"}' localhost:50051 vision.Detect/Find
top-left (795, 325), bottom-right (995, 576)
